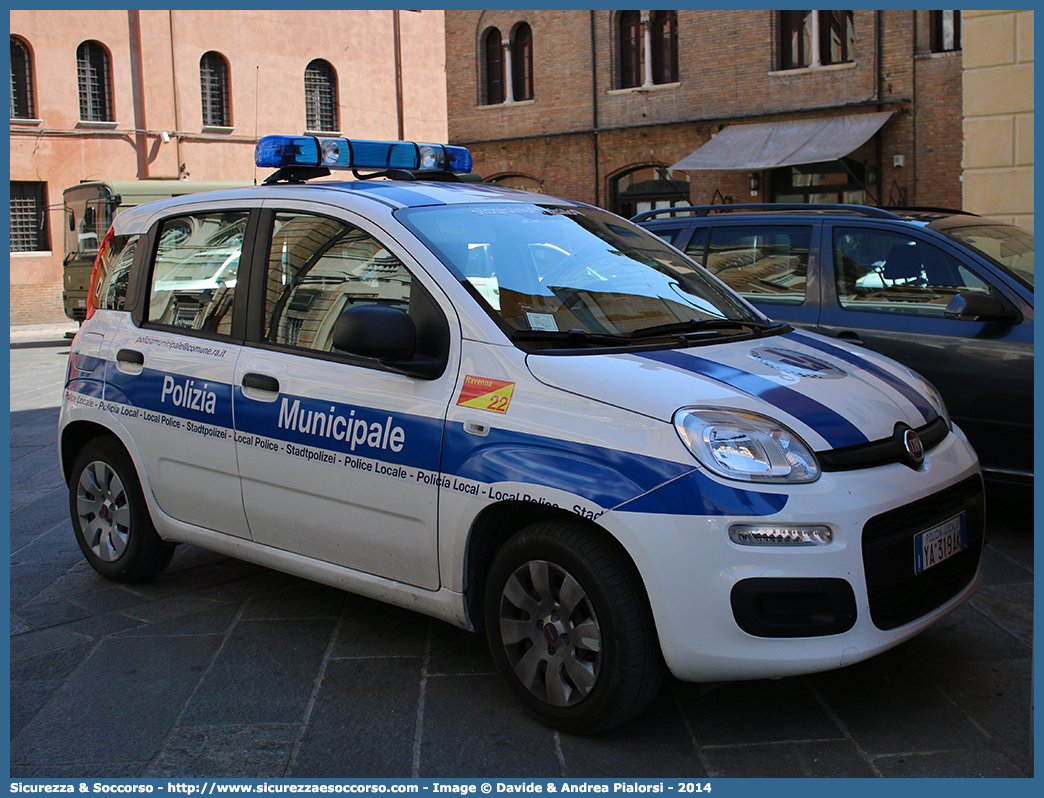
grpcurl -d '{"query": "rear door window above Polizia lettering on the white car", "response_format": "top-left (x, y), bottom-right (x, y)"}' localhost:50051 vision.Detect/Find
top-left (148, 211), bottom-right (250, 335)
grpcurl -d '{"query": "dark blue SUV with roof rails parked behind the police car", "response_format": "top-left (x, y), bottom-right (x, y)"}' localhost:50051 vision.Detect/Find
top-left (633, 204), bottom-right (1034, 493)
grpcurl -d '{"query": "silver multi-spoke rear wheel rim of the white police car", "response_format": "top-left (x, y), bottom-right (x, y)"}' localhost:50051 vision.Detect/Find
top-left (76, 461), bottom-right (131, 562)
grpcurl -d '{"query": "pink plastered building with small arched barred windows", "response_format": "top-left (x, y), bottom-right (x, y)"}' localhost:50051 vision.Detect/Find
top-left (10, 9), bottom-right (447, 323)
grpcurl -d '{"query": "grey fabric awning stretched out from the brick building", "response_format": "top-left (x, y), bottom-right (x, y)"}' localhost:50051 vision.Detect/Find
top-left (670, 111), bottom-right (893, 171)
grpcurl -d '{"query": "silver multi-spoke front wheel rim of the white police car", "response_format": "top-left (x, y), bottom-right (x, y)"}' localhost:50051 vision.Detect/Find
top-left (500, 560), bottom-right (601, 707)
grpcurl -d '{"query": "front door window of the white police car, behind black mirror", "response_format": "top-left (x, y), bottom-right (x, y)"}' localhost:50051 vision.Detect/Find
top-left (265, 212), bottom-right (413, 352)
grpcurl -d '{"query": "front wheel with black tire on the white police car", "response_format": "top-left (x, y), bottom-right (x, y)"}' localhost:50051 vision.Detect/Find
top-left (485, 521), bottom-right (664, 734)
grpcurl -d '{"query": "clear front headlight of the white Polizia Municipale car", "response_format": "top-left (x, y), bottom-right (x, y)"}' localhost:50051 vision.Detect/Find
top-left (674, 407), bottom-right (820, 484)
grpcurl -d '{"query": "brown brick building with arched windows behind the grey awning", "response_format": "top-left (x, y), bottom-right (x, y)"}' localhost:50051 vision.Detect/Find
top-left (446, 9), bottom-right (962, 214)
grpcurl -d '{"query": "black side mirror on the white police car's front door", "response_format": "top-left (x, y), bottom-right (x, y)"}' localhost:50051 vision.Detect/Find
top-left (332, 305), bottom-right (445, 379)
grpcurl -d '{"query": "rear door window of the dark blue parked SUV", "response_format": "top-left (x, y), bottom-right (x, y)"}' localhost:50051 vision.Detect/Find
top-left (687, 225), bottom-right (812, 305)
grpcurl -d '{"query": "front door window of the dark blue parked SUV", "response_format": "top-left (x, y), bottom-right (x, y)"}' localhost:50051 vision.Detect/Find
top-left (833, 228), bottom-right (993, 318)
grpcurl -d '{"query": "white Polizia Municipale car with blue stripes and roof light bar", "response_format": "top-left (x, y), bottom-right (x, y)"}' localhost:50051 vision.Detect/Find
top-left (60, 137), bottom-right (983, 733)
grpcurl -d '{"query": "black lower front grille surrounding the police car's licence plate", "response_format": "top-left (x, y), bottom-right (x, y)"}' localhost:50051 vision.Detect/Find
top-left (862, 475), bottom-right (986, 630)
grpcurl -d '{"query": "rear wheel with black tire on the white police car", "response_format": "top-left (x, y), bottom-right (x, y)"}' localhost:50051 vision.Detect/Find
top-left (69, 438), bottom-right (174, 582)
